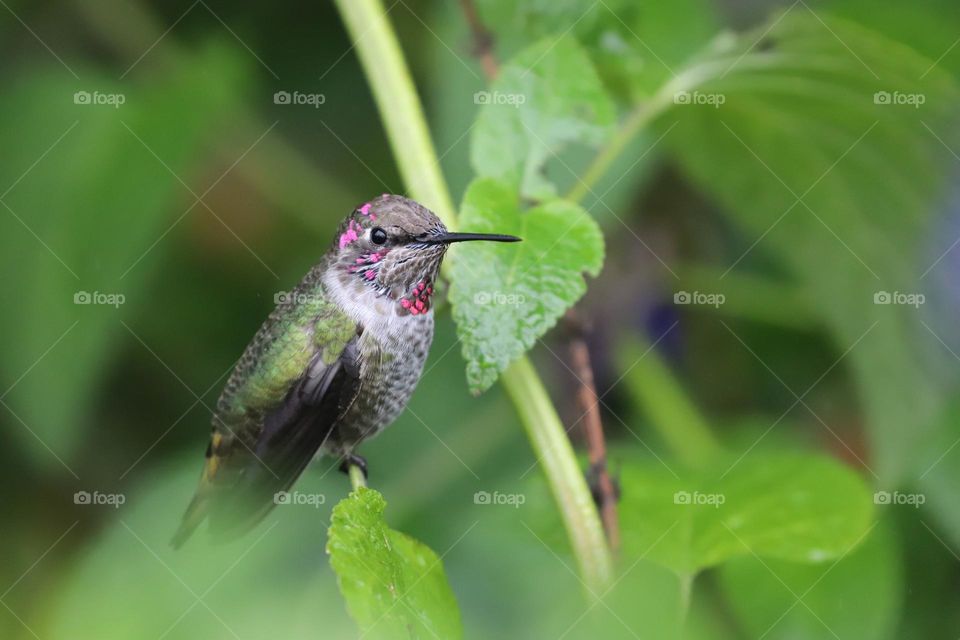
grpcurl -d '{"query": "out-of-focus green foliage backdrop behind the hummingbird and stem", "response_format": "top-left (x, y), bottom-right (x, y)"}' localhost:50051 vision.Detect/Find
top-left (0, 0), bottom-right (960, 640)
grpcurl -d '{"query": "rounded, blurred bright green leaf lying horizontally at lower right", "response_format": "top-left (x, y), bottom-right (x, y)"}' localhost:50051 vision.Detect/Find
top-left (620, 454), bottom-right (873, 574)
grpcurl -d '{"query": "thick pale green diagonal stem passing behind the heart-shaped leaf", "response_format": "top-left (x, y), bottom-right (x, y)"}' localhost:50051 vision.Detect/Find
top-left (336, 0), bottom-right (613, 593)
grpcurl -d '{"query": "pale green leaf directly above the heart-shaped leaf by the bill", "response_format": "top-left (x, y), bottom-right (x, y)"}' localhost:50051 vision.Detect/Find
top-left (470, 37), bottom-right (614, 199)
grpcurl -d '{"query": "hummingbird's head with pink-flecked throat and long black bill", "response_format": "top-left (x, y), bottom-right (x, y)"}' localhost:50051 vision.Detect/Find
top-left (332, 193), bottom-right (520, 315)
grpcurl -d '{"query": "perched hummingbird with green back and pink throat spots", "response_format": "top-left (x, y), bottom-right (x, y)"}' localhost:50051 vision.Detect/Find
top-left (172, 194), bottom-right (520, 548)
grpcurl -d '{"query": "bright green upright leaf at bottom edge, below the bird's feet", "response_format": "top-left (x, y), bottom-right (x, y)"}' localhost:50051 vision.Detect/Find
top-left (327, 487), bottom-right (462, 638)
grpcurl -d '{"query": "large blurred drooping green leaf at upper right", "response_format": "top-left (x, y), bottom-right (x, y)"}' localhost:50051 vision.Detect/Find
top-left (659, 12), bottom-right (960, 484)
